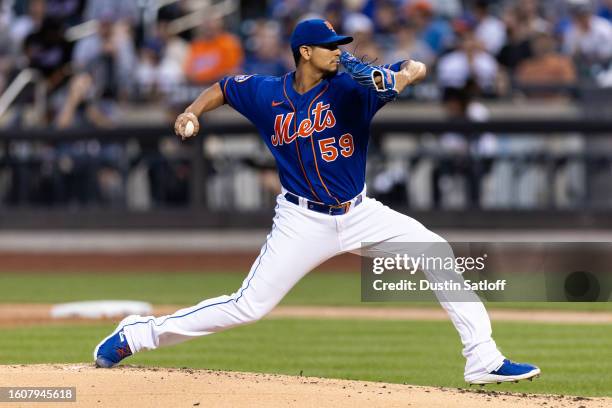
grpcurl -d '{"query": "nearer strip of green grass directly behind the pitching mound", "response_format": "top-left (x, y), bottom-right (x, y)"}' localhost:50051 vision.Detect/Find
top-left (0, 319), bottom-right (612, 397)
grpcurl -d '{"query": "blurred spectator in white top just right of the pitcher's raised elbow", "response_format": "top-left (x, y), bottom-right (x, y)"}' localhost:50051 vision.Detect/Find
top-left (438, 30), bottom-right (498, 96)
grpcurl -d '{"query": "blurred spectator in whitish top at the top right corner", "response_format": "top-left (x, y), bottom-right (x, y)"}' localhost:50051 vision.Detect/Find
top-left (563, 0), bottom-right (612, 75)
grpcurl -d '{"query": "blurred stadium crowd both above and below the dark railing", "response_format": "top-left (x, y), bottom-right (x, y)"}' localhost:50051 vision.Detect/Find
top-left (0, 0), bottom-right (612, 214)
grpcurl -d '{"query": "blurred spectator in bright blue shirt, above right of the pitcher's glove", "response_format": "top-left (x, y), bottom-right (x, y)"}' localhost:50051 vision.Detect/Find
top-left (404, 0), bottom-right (454, 55)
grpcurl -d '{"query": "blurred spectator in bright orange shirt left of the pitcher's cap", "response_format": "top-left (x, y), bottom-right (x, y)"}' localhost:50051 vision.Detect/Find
top-left (185, 18), bottom-right (244, 84)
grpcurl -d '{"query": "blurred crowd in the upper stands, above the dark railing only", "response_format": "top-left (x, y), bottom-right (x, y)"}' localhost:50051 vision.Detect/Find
top-left (0, 0), bottom-right (612, 128)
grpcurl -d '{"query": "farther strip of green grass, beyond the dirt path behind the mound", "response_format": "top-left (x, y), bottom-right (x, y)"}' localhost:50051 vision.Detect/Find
top-left (0, 272), bottom-right (612, 310)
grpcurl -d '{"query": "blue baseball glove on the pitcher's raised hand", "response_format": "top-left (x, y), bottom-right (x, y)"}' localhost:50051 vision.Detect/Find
top-left (340, 51), bottom-right (399, 102)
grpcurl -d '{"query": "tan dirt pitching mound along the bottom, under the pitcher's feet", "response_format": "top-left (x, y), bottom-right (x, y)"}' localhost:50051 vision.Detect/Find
top-left (0, 364), bottom-right (612, 408)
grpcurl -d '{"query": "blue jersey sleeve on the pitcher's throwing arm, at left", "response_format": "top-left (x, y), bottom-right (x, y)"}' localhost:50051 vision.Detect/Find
top-left (219, 75), bottom-right (265, 123)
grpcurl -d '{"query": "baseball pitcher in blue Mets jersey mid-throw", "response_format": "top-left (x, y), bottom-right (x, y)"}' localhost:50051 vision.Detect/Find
top-left (94, 19), bottom-right (540, 384)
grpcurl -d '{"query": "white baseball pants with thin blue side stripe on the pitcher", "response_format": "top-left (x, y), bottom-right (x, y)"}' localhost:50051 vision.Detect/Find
top-left (124, 195), bottom-right (503, 381)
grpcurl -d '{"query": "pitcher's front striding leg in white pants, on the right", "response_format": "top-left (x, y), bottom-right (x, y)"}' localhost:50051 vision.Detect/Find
top-left (340, 198), bottom-right (504, 382)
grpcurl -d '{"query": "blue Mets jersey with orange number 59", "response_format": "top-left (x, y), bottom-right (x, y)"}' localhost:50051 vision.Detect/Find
top-left (219, 61), bottom-right (403, 205)
